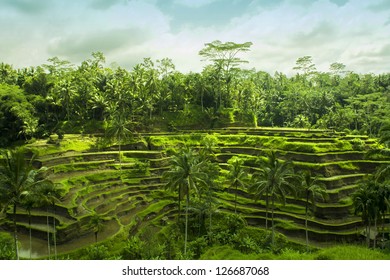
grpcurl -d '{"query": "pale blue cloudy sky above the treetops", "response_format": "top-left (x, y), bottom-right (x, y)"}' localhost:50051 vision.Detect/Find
top-left (0, 0), bottom-right (390, 74)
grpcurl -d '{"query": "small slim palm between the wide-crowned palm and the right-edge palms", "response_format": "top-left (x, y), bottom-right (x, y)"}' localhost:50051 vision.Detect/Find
top-left (300, 171), bottom-right (327, 250)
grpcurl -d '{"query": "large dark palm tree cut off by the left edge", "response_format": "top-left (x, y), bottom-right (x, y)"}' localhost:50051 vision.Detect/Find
top-left (0, 148), bottom-right (47, 259)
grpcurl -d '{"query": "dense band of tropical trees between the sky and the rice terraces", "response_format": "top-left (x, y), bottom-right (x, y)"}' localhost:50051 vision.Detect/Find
top-left (0, 41), bottom-right (390, 146)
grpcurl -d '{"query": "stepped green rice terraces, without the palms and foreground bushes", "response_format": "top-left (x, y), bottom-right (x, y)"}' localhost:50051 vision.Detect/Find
top-left (1, 128), bottom-right (390, 256)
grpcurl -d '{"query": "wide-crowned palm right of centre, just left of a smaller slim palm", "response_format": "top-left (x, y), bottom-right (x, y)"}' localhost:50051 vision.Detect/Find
top-left (250, 151), bottom-right (295, 244)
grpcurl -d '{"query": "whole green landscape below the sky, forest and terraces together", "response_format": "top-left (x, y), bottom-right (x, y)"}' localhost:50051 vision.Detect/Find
top-left (0, 40), bottom-right (390, 260)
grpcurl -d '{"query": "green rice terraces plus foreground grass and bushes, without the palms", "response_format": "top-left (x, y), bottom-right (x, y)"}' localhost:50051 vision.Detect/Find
top-left (1, 128), bottom-right (390, 259)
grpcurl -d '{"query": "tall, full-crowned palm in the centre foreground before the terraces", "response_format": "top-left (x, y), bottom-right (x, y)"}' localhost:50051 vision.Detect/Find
top-left (164, 148), bottom-right (207, 255)
